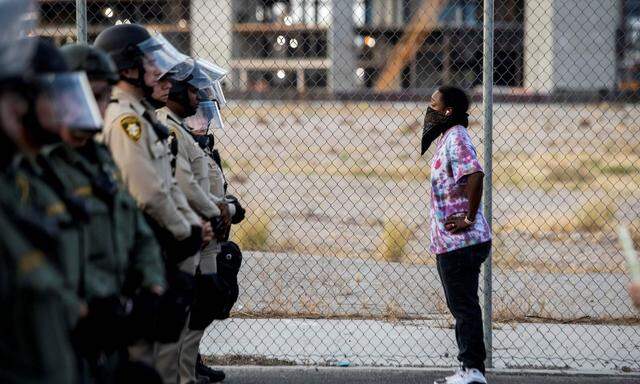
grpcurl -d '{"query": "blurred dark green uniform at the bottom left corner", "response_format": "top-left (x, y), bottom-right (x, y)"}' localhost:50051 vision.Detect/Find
top-left (0, 178), bottom-right (79, 384)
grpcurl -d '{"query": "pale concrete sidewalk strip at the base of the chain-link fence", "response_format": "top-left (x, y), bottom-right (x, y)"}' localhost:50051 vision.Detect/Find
top-left (200, 319), bottom-right (640, 372)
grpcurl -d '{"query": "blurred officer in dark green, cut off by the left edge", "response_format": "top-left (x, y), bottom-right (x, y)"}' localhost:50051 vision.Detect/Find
top-left (0, 4), bottom-right (80, 383)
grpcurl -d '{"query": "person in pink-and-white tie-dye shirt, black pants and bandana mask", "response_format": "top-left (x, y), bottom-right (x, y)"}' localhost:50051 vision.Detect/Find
top-left (422, 87), bottom-right (491, 384)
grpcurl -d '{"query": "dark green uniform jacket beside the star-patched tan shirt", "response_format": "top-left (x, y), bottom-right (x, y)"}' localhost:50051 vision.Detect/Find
top-left (42, 142), bottom-right (165, 297)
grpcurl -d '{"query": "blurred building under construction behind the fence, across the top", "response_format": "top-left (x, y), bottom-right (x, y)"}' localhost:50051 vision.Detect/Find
top-left (40, 0), bottom-right (640, 94)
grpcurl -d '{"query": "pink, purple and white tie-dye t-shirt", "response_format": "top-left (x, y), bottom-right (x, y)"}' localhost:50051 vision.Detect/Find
top-left (431, 125), bottom-right (491, 254)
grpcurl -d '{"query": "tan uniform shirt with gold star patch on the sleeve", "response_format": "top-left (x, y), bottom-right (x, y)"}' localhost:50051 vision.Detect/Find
top-left (102, 88), bottom-right (195, 240)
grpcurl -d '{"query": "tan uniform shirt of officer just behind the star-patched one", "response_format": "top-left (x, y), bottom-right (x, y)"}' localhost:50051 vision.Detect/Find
top-left (157, 107), bottom-right (220, 219)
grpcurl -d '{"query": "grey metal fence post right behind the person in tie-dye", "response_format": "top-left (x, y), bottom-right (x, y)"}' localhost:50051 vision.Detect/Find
top-left (482, 0), bottom-right (494, 368)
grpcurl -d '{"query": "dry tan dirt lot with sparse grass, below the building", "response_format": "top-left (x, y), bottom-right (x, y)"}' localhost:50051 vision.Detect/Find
top-left (218, 102), bottom-right (640, 272)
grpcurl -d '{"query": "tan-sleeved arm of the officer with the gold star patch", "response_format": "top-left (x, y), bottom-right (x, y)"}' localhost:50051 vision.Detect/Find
top-left (106, 116), bottom-right (191, 240)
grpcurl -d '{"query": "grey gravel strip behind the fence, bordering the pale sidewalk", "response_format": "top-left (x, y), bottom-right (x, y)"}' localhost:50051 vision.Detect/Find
top-left (236, 252), bottom-right (637, 320)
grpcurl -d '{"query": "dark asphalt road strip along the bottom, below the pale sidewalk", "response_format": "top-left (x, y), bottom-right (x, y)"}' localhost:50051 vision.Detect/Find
top-left (218, 367), bottom-right (640, 384)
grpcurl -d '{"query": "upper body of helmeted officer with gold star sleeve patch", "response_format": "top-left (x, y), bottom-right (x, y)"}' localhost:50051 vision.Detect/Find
top-left (94, 24), bottom-right (202, 262)
